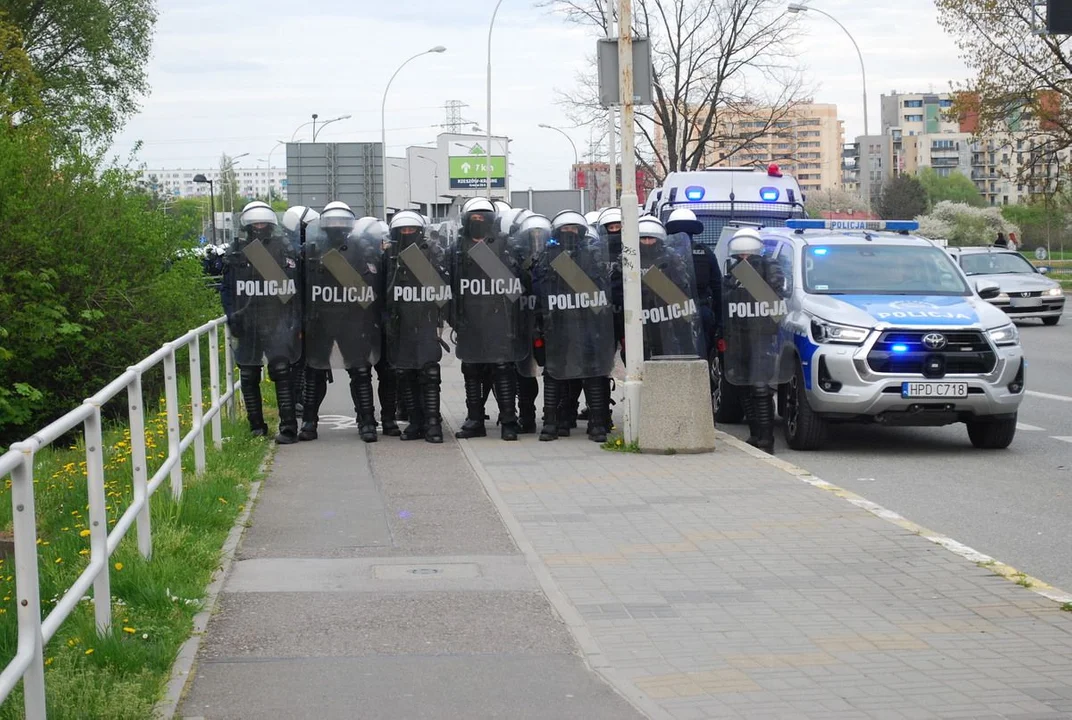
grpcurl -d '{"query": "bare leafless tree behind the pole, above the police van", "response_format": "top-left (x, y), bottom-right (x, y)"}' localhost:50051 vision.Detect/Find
top-left (537, 0), bottom-right (807, 179)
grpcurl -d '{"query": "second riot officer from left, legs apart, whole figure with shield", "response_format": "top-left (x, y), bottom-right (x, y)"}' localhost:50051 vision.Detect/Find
top-left (298, 203), bottom-right (383, 443)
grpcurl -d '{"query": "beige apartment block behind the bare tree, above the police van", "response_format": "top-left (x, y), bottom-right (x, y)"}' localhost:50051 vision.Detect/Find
top-left (706, 103), bottom-right (845, 194)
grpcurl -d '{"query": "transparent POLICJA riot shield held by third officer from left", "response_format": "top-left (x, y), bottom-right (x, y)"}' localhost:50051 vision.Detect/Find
top-left (384, 229), bottom-right (452, 370)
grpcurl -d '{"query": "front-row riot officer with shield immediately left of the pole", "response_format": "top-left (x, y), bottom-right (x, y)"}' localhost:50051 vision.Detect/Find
top-left (534, 210), bottom-right (614, 443)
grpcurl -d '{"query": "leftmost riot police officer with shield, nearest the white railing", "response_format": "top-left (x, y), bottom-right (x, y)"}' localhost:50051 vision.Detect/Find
top-left (222, 203), bottom-right (301, 445)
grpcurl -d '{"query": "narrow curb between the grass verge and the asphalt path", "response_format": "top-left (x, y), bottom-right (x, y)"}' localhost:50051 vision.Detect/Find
top-left (153, 443), bottom-right (278, 720)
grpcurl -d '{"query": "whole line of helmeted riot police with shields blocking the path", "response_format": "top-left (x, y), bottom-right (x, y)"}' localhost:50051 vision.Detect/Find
top-left (222, 198), bottom-right (788, 456)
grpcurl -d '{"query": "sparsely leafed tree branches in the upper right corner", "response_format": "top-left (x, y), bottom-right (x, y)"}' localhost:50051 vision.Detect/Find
top-left (936, 0), bottom-right (1072, 193)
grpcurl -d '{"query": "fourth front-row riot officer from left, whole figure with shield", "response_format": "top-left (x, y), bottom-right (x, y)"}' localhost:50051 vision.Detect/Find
top-left (450, 197), bottom-right (527, 440)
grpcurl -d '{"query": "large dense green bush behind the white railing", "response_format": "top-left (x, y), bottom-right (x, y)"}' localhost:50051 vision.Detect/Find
top-left (0, 125), bottom-right (220, 444)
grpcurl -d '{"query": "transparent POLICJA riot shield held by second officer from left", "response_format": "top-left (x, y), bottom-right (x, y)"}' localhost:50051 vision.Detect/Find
top-left (304, 220), bottom-right (384, 370)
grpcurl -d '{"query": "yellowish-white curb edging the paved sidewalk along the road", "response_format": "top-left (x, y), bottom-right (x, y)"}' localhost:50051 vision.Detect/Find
top-left (715, 430), bottom-right (1072, 604)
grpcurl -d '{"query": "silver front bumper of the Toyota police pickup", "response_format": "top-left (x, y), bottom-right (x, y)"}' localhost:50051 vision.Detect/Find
top-left (804, 333), bottom-right (1024, 425)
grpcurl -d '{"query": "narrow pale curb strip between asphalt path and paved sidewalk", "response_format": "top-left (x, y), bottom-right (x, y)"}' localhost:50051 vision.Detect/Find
top-left (443, 417), bottom-right (673, 720)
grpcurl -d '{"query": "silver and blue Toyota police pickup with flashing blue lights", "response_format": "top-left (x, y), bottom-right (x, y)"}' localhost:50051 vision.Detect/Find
top-left (716, 220), bottom-right (1026, 450)
